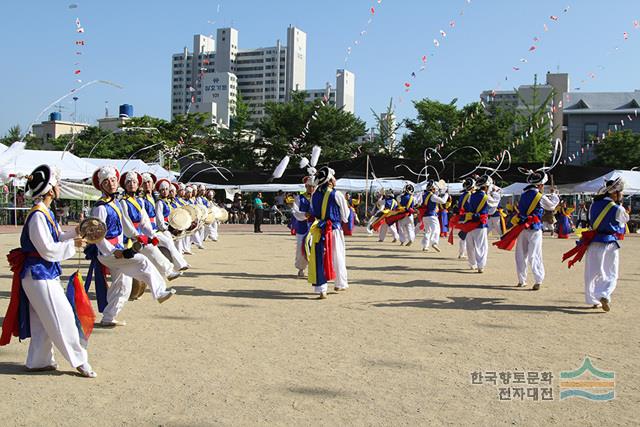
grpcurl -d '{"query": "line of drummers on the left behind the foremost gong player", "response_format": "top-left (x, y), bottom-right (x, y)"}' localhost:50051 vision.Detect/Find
top-left (0, 165), bottom-right (225, 378)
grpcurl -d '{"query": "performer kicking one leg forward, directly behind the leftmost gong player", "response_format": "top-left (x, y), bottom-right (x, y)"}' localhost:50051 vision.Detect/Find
top-left (92, 166), bottom-right (175, 327)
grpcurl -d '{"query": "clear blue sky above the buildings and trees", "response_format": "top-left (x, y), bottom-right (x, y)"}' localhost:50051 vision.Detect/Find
top-left (0, 0), bottom-right (640, 135)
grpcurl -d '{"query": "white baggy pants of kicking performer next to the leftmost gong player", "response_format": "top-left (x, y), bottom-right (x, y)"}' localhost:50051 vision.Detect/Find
top-left (98, 254), bottom-right (169, 322)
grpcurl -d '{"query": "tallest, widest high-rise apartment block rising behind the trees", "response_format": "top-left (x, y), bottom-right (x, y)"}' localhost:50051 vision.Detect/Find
top-left (171, 27), bottom-right (307, 126)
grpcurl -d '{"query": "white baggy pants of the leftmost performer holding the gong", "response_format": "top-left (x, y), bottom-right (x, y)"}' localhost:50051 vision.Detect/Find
top-left (22, 272), bottom-right (88, 369)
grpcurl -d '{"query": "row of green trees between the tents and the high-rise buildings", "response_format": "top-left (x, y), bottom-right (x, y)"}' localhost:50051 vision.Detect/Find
top-left (0, 92), bottom-right (640, 170)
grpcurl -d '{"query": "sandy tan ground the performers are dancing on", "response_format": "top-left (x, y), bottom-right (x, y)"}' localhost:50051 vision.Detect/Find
top-left (0, 226), bottom-right (640, 426)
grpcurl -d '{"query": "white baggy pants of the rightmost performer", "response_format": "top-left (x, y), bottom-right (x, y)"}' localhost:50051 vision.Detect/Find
top-left (584, 242), bottom-right (620, 304)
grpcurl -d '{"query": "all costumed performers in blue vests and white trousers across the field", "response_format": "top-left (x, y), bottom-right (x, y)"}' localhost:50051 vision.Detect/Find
top-left (0, 165), bottom-right (629, 377)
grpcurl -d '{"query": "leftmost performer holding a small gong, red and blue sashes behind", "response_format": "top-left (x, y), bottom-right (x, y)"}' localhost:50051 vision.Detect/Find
top-left (0, 165), bottom-right (96, 378)
